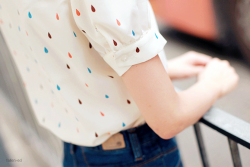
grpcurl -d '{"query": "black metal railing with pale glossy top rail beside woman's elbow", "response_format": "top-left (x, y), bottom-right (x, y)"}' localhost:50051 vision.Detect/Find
top-left (194, 107), bottom-right (250, 167)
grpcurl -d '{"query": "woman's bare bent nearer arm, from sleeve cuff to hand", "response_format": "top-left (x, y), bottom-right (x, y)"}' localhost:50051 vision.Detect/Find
top-left (122, 56), bottom-right (238, 139)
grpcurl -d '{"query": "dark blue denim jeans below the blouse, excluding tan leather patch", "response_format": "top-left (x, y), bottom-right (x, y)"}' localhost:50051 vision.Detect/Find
top-left (63, 124), bottom-right (182, 167)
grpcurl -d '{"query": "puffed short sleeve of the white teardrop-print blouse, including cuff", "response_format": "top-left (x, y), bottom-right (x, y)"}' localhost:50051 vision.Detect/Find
top-left (71, 0), bottom-right (166, 76)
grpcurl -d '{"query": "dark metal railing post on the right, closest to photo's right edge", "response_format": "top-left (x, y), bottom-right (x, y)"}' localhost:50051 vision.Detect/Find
top-left (228, 138), bottom-right (242, 167)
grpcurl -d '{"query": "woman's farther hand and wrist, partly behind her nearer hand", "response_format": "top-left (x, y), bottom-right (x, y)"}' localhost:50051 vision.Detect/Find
top-left (168, 51), bottom-right (212, 79)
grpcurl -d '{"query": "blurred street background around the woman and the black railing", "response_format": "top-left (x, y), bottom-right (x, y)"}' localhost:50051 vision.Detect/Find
top-left (0, 0), bottom-right (250, 167)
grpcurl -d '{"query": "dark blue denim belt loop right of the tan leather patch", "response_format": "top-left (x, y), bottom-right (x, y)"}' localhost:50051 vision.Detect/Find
top-left (128, 128), bottom-right (143, 161)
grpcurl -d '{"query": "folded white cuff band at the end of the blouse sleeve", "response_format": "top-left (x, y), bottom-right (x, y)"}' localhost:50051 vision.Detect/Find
top-left (103, 30), bottom-right (167, 76)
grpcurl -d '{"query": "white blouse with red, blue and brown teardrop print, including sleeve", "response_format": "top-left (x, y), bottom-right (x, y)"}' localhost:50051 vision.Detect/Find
top-left (0, 0), bottom-right (167, 146)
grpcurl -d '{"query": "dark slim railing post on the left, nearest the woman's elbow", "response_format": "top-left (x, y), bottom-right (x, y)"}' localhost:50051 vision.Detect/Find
top-left (194, 122), bottom-right (209, 167)
